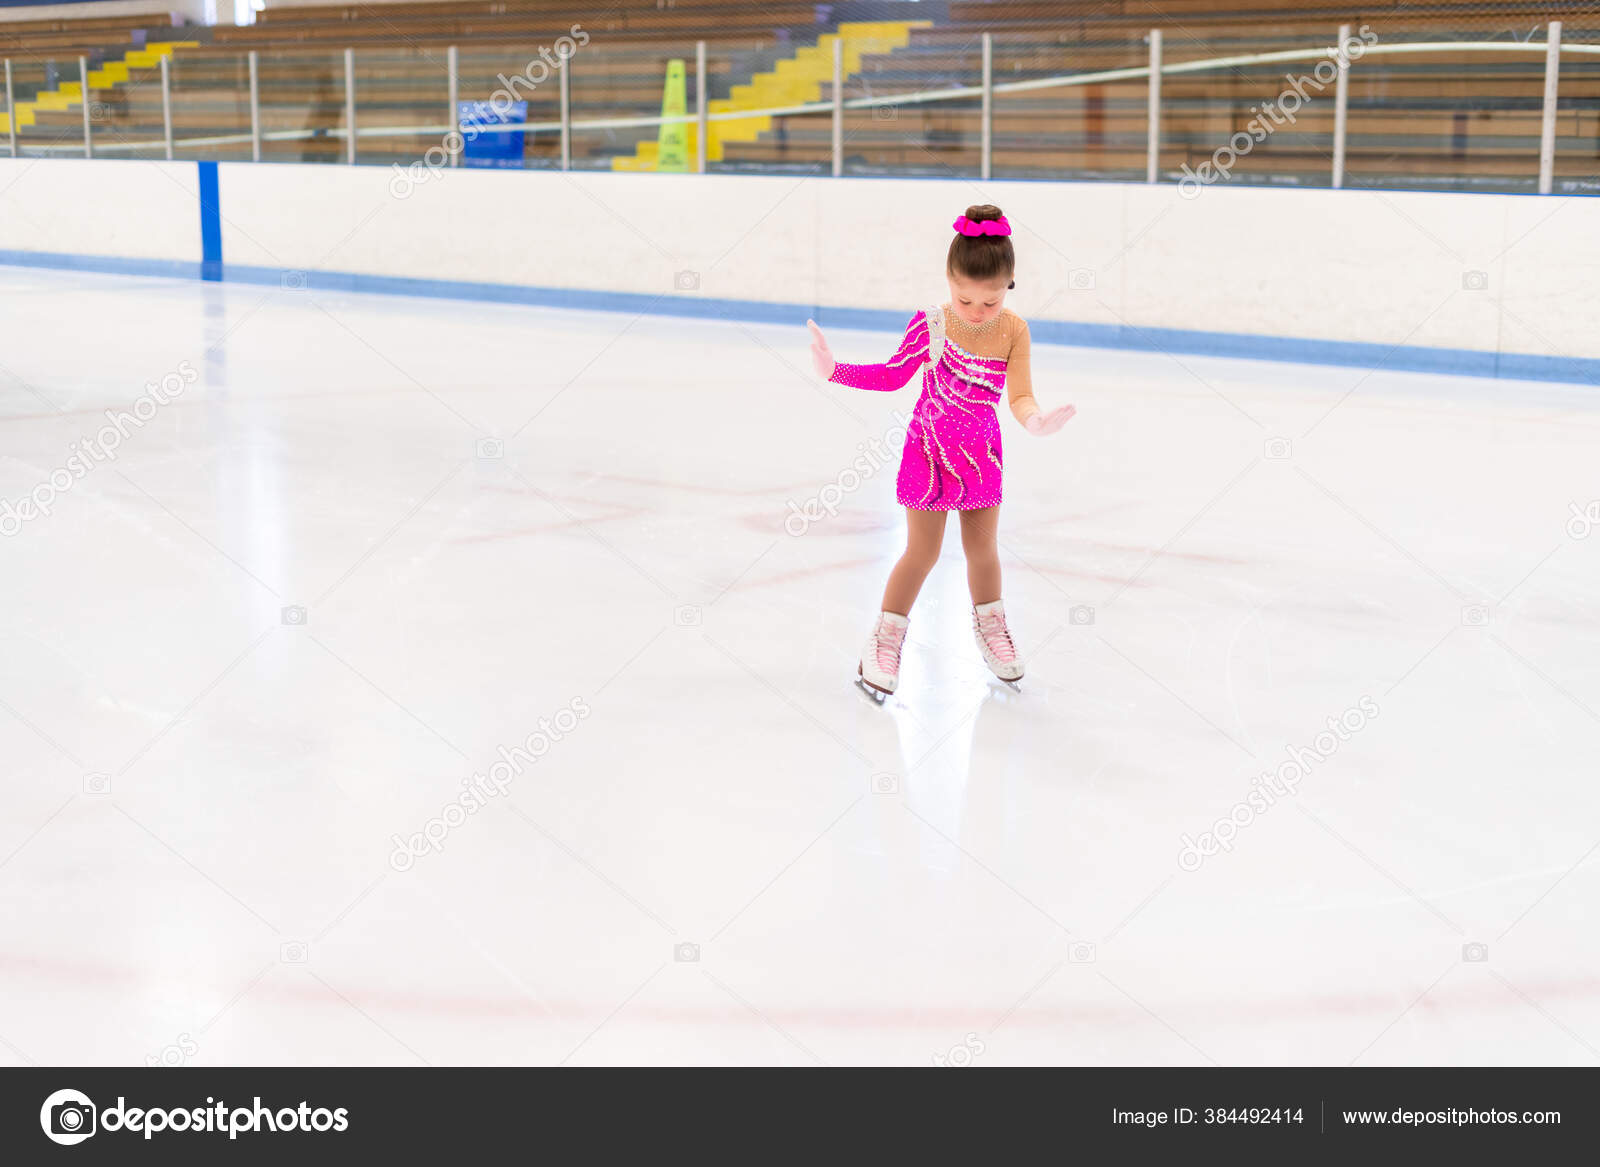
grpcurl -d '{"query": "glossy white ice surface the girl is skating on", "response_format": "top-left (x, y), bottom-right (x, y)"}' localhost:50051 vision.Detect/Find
top-left (0, 269), bottom-right (1600, 1066)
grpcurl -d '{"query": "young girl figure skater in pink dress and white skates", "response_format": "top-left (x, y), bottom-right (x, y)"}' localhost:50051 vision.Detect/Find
top-left (806, 205), bottom-right (1077, 701)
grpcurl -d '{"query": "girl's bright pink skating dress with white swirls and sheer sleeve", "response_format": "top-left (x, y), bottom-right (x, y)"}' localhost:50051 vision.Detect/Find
top-left (829, 307), bottom-right (1037, 511)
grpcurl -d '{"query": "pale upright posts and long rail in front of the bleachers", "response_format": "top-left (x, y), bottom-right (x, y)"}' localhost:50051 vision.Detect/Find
top-left (5, 21), bottom-right (1600, 194)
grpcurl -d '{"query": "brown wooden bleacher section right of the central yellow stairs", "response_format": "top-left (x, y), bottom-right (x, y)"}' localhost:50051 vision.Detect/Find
top-left (728, 0), bottom-right (1600, 186)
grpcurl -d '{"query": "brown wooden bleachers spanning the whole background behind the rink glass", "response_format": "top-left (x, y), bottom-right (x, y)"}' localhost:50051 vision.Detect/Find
top-left (0, 0), bottom-right (1600, 184)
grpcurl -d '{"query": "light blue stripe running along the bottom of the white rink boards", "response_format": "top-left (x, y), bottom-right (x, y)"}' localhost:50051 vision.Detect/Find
top-left (0, 248), bottom-right (1600, 386)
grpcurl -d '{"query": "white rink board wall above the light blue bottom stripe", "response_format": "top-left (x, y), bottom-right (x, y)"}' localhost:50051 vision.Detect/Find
top-left (0, 158), bottom-right (1600, 361)
